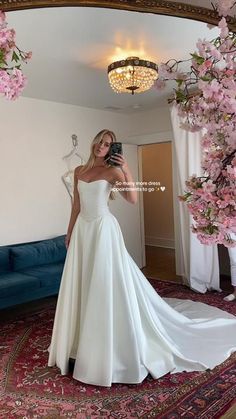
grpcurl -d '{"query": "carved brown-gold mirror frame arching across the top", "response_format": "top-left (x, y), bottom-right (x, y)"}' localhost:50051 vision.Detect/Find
top-left (0, 0), bottom-right (236, 29)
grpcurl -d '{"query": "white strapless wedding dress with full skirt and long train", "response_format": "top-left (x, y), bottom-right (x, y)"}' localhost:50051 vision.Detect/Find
top-left (48, 180), bottom-right (236, 386)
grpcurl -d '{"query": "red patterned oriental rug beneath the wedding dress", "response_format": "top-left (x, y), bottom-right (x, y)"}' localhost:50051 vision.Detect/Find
top-left (0, 280), bottom-right (236, 419)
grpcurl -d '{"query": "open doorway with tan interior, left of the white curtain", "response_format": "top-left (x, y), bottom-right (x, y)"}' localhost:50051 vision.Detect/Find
top-left (139, 141), bottom-right (181, 281)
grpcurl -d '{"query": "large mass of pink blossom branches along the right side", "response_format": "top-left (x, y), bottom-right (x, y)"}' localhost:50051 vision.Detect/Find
top-left (156, 0), bottom-right (236, 246)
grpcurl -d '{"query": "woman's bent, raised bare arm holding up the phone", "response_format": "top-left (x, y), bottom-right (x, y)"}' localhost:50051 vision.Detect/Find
top-left (112, 154), bottom-right (138, 204)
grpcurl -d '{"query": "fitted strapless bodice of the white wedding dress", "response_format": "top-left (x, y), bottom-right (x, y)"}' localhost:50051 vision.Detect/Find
top-left (78, 179), bottom-right (112, 221)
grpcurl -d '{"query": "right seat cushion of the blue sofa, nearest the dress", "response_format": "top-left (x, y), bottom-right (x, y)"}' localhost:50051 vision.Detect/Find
top-left (21, 263), bottom-right (64, 287)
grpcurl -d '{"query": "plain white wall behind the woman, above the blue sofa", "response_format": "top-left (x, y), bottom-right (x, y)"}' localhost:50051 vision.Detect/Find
top-left (0, 97), bottom-right (129, 245)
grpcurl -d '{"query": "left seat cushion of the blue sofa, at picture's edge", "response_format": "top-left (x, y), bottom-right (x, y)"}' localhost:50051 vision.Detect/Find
top-left (0, 272), bottom-right (40, 299)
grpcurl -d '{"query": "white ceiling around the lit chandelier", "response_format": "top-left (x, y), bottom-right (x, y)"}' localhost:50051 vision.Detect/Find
top-left (7, 5), bottom-right (221, 113)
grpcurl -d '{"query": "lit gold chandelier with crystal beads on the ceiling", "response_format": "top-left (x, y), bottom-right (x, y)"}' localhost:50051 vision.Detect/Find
top-left (107, 57), bottom-right (158, 95)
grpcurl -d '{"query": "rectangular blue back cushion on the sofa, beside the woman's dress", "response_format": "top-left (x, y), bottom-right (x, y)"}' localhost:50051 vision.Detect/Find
top-left (10, 236), bottom-right (66, 271)
